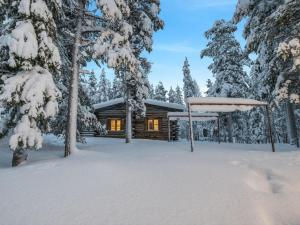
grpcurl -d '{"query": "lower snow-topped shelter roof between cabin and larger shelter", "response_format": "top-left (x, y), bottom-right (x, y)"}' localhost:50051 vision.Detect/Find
top-left (168, 112), bottom-right (218, 121)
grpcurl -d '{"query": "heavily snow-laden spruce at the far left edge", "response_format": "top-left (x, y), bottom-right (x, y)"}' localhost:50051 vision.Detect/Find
top-left (0, 0), bottom-right (61, 166)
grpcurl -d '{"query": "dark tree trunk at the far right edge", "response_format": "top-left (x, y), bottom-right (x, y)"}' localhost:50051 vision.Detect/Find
top-left (286, 101), bottom-right (299, 147)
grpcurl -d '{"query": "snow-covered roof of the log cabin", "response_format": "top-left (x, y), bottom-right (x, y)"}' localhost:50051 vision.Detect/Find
top-left (93, 98), bottom-right (185, 110)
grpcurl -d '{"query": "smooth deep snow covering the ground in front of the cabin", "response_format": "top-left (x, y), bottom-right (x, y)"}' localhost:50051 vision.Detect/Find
top-left (0, 137), bottom-right (300, 225)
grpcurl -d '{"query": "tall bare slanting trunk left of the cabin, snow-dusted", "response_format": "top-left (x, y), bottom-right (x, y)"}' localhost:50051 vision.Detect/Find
top-left (65, 0), bottom-right (85, 157)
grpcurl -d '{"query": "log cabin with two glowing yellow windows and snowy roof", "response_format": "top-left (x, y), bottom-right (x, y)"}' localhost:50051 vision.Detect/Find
top-left (94, 98), bottom-right (185, 140)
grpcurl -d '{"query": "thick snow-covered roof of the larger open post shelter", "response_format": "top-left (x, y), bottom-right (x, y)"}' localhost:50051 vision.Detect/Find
top-left (187, 97), bottom-right (268, 112)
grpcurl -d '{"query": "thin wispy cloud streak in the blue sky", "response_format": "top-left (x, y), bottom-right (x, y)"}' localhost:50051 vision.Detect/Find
top-left (154, 43), bottom-right (200, 53)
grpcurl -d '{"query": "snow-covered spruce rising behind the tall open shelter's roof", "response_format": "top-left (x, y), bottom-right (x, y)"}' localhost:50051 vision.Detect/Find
top-left (201, 20), bottom-right (249, 142)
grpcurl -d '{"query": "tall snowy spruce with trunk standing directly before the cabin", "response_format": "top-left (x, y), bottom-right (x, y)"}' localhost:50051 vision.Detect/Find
top-left (94, 0), bottom-right (163, 143)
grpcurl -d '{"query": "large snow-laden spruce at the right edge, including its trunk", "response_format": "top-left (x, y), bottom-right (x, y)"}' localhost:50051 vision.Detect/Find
top-left (234, 0), bottom-right (299, 144)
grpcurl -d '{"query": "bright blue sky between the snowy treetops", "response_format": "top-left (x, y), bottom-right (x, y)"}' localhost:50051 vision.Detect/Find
top-left (89, 0), bottom-right (243, 91)
